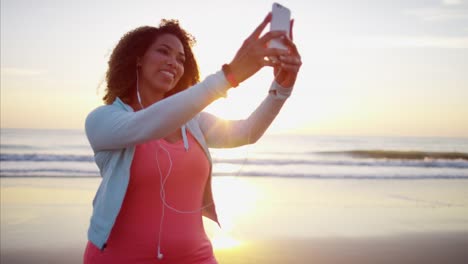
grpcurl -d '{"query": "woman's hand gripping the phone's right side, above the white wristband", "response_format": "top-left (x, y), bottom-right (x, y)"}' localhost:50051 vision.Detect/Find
top-left (274, 20), bottom-right (302, 88)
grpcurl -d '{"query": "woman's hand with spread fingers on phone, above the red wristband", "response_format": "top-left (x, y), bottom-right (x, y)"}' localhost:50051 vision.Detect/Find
top-left (229, 13), bottom-right (289, 83)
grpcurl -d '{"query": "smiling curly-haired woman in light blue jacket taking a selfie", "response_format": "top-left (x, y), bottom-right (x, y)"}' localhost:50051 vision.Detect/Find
top-left (84, 14), bottom-right (301, 264)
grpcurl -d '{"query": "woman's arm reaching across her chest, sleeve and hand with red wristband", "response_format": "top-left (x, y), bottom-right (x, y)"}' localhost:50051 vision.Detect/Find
top-left (85, 15), bottom-right (287, 152)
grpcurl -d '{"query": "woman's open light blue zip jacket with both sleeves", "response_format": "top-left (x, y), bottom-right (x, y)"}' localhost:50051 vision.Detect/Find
top-left (85, 71), bottom-right (292, 249)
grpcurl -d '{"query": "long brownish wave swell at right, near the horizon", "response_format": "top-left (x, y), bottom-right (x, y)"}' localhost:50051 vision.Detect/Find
top-left (313, 150), bottom-right (468, 161)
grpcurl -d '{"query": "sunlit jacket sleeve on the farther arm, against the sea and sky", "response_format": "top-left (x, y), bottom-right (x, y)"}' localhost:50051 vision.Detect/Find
top-left (198, 82), bottom-right (292, 148)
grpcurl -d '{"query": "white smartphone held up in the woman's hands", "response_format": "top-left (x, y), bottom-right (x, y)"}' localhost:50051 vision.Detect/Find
top-left (268, 3), bottom-right (291, 49)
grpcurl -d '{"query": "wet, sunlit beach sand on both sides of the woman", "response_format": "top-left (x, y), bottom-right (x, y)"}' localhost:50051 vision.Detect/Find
top-left (0, 177), bottom-right (468, 264)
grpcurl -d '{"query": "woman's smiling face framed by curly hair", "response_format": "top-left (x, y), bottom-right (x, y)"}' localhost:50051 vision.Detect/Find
top-left (139, 34), bottom-right (185, 101)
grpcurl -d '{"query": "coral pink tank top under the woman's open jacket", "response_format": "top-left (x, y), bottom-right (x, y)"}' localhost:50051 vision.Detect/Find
top-left (85, 133), bottom-right (217, 264)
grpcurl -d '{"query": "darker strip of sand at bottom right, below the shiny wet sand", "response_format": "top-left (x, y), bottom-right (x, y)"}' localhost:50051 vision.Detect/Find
top-left (216, 233), bottom-right (468, 264)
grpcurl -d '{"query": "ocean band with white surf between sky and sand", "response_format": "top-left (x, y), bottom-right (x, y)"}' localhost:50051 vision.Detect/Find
top-left (0, 128), bottom-right (468, 180)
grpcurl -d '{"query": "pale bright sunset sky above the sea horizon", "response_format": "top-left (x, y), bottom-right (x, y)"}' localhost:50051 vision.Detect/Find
top-left (0, 0), bottom-right (468, 137)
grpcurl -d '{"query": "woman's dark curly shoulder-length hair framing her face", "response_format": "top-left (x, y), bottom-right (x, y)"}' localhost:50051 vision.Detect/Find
top-left (102, 19), bottom-right (200, 104)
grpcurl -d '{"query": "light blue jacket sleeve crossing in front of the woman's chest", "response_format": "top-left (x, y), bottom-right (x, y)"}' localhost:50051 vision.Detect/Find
top-left (85, 71), bottom-right (230, 152)
